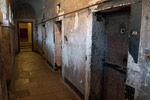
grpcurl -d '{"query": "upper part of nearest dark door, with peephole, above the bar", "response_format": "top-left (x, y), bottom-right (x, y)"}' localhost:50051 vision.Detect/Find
top-left (106, 14), bottom-right (129, 67)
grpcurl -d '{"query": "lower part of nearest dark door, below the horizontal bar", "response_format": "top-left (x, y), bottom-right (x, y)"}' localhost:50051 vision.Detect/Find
top-left (104, 66), bottom-right (126, 100)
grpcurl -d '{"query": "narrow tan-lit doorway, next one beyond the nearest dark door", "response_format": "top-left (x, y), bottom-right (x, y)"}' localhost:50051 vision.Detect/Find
top-left (54, 21), bottom-right (62, 69)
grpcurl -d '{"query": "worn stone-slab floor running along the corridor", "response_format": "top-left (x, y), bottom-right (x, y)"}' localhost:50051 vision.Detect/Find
top-left (12, 52), bottom-right (80, 100)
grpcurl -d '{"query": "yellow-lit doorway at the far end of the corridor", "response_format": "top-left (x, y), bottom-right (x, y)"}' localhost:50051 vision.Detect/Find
top-left (18, 22), bottom-right (33, 52)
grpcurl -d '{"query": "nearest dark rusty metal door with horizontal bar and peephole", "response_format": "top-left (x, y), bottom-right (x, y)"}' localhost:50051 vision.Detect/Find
top-left (103, 12), bottom-right (130, 100)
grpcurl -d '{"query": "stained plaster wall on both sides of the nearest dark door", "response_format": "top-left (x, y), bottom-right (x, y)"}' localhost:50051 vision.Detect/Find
top-left (12, 0), bottom-right (150, 100)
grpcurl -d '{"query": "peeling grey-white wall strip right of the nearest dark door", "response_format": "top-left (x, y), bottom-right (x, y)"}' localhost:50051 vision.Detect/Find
top-left (127, 0), bottom-right (150, 100)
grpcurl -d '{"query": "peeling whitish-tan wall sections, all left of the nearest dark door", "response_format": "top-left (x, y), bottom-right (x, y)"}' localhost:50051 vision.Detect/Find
top-left (33, 0), bottom-right (95, 98)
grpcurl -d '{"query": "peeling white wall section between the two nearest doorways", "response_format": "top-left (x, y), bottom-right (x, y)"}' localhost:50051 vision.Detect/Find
top-left (63, 11), bottom-right (92, 98)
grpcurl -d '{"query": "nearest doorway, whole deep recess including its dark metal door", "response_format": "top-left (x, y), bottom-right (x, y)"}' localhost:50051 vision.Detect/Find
top-left (90, 11), bottom-right (130, 100)
